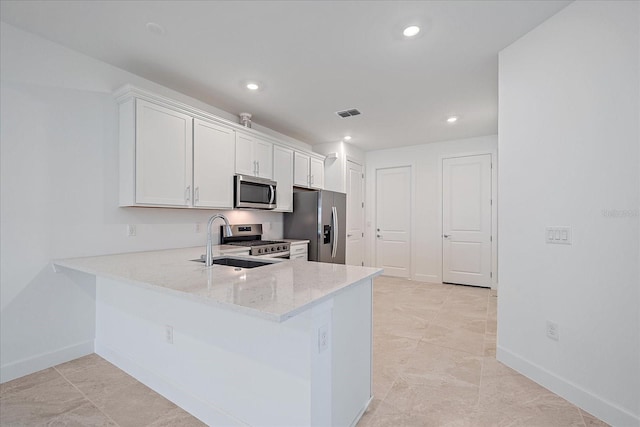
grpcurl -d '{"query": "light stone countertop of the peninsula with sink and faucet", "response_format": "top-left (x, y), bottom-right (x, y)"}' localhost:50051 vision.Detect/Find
top-left (53, 245), bottom-right (382, 322)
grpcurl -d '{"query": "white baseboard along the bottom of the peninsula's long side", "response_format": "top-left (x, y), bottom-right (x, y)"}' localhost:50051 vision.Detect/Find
top-left (95, 341), bottom-right (248, 427)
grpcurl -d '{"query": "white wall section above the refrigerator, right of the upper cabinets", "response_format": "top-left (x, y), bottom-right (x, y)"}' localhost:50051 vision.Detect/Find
top-left (313, 142), bottom-right (365, 193)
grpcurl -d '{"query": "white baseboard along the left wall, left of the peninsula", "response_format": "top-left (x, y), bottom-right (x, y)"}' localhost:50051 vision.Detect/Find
top-left (0, 340), bottom-right (94, 383)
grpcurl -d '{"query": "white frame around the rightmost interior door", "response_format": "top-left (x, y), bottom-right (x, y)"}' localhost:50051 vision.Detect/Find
top-left (438, 150), bottom-right (498, 289)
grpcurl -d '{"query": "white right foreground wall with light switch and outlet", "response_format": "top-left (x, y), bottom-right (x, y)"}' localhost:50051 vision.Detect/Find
top-left (497, 1), bottom-right (640, 426)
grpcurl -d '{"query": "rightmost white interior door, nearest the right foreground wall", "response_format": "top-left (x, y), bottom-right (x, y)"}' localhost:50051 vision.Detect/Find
top-left (442, 154), bottom-right (491, 287)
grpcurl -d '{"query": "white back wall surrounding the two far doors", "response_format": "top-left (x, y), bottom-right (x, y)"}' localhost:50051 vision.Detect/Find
top-left (365, 135), bottom-right (498, 286)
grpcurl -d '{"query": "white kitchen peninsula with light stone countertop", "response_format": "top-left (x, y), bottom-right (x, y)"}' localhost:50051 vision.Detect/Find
top-left (54, 247), bottom-right (382, 426)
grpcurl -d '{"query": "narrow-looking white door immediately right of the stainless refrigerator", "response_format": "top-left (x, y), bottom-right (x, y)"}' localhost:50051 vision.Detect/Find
top-left (346, 160), bottom-right (364, 265)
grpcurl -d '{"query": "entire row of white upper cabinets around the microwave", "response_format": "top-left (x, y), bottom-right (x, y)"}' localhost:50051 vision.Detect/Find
top-left (115, 85), bottom-right (324, 212)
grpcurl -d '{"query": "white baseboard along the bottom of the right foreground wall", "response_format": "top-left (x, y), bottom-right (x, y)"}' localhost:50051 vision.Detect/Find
top-left (496, 346), bottom-right (640, 426)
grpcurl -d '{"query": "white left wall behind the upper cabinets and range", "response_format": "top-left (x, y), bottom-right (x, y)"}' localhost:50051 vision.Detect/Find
top-left (0, 23), bottom-right (302, 381)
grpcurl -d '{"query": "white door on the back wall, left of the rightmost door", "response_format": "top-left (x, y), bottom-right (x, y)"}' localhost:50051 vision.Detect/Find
top-left (376, 167), bottom-right (411, 277)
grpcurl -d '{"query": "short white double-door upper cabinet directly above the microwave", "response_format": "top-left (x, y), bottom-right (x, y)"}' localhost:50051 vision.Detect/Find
top-left (236, 132), bottom-right (273, 179)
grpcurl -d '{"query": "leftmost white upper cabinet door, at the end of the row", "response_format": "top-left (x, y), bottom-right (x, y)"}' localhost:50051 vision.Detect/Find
top-left (136, 100), bottom-right (193, 206)
